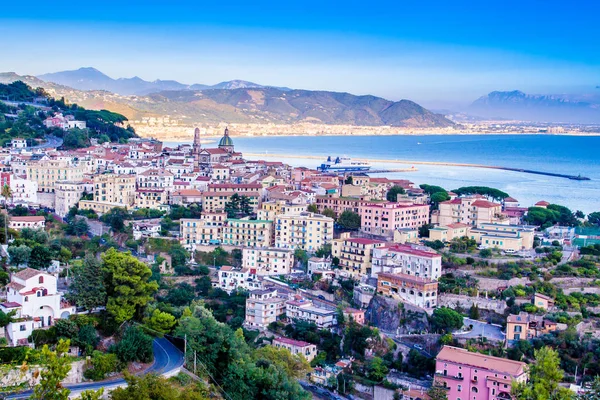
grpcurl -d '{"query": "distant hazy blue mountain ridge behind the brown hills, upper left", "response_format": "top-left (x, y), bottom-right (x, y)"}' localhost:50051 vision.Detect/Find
top-left (38, 67), bottom-right (290, 95)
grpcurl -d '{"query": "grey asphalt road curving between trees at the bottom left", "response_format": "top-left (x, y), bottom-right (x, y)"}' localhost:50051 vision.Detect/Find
top-left (6, 338), bottom-right (183, 399)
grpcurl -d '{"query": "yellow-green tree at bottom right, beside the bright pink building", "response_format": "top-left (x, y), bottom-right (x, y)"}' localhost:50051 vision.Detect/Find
top-left (512, 347), bottom-right (573, 400)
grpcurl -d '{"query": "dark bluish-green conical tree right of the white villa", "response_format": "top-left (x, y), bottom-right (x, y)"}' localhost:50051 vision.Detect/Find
top-left (67, 255), bottom-right (106, 310)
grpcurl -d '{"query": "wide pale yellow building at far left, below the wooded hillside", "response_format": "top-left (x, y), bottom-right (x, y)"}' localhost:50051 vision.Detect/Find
top-left (26, 160), bottom-right (89, 193)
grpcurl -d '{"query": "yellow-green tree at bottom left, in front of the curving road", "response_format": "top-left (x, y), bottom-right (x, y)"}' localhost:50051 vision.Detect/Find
top-left (30, 340), bottom-right (71, 400)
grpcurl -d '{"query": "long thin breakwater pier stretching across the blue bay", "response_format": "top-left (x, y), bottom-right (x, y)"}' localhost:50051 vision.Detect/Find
top-left (245, 153), bottom-right (590, 181)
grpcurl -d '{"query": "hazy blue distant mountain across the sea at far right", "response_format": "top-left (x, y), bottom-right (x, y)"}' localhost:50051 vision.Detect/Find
top-left (467, 90), bottom-right (600, 124)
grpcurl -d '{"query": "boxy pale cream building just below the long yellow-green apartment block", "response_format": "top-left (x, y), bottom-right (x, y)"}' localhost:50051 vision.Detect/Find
top-left (242, 247), bottom-right (294, 276)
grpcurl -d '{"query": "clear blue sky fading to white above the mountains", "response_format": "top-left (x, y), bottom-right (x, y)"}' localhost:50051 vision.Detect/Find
top-left (0, 0), bottom-right (600, 108)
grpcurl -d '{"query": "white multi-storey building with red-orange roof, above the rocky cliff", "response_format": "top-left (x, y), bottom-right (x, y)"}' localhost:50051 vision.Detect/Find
top-left (370, 243), bottom-right (442, 281)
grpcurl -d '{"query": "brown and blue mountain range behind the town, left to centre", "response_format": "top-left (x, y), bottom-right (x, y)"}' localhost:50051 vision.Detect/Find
top-left (0, 69), bottom-right (454, 128)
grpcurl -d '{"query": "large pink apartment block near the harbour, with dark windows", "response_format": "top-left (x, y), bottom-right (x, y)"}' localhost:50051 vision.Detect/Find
top-left (359, 201), bottom-right (429, 236)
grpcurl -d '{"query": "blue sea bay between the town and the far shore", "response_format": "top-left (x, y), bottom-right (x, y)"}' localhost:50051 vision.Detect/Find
top-left (165, 134), bottom-right (600, 214)
